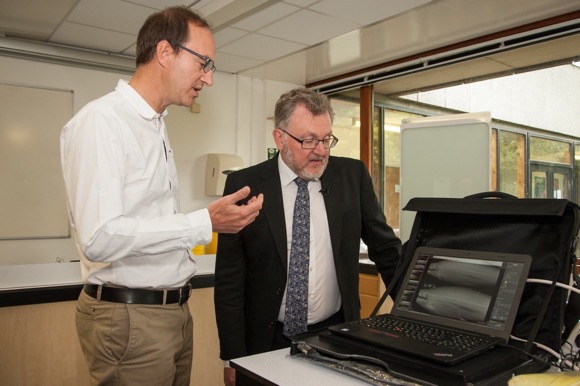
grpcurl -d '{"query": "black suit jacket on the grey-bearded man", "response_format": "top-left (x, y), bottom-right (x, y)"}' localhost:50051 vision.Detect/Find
top-left (215, 157), bottom-right (401, 360)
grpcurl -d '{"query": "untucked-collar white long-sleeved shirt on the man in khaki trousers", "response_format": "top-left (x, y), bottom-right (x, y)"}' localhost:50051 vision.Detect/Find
top-left (60, 80), bottom-right (212, 288)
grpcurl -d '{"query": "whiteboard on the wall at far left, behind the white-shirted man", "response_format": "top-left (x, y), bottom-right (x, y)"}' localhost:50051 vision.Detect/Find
top-left (0, 84), bottom-right (73, 239)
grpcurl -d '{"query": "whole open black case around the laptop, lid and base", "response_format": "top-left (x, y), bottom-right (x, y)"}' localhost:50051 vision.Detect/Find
top-left (291, 192), bottom-right (580, 386)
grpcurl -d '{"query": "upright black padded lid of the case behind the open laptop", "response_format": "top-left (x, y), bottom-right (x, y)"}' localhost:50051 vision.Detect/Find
top-left (401, 192), bottom-right (580, 351)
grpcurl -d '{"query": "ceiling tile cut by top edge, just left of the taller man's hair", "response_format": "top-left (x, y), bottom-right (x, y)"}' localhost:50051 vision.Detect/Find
top-left (67, 0), bottom-right (156, 36)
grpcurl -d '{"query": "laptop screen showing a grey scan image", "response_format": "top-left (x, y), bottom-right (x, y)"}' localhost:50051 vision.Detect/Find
top-left (391, 247), bottom-right (531, 339)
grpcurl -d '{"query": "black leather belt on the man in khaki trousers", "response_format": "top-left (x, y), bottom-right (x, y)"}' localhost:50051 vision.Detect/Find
top-left (83, 283), bottom-right (191, 305)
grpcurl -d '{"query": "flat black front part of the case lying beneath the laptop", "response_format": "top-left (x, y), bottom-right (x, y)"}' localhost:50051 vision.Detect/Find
top-left (290, 329), bottom-right (547, 386)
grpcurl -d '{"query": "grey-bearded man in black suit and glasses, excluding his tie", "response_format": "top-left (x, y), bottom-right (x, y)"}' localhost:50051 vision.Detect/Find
top-left (215, 89), bottom-right (401, 385)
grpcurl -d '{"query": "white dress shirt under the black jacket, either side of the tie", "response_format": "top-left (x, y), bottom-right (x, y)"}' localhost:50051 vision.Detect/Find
top-left (278, 157), bottom-right (342, 325)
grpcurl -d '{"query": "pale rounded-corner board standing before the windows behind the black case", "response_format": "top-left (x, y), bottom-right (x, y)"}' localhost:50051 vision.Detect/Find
top-left (399, 112), bottom-right (491, 242)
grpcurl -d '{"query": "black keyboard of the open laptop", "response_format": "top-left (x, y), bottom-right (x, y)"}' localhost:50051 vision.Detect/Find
top-left (353, 316), bottom-right (488, 352)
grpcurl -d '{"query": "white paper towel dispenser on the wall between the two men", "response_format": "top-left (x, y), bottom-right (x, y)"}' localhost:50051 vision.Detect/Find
top-left (205, 153), bottom-right (244, 196)
